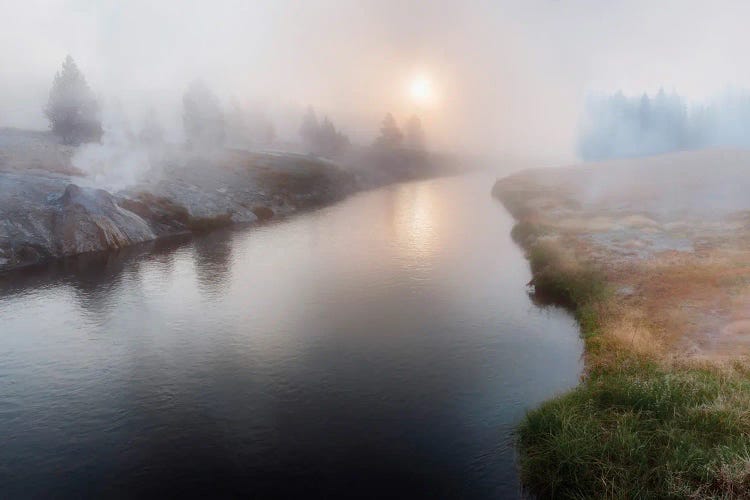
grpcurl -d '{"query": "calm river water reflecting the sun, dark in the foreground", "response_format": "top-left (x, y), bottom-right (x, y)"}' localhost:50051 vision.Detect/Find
top-left (0, 175), bottom-right (581, 498)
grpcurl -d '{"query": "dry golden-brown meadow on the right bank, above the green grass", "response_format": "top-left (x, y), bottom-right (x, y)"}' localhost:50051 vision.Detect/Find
top-left (494, 170), bottom-right (750, 362)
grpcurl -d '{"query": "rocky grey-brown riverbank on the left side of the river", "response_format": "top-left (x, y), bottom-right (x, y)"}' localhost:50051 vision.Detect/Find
top-left (0, 130), bottom-right (452, 271)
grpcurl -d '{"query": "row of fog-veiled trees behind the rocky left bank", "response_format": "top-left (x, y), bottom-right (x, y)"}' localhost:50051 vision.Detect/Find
top-left (44, 56), bottom-right (425, 157)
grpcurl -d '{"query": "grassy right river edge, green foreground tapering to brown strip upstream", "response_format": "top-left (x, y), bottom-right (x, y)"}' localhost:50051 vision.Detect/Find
top-left (513, 220), bottom-right (750, 498)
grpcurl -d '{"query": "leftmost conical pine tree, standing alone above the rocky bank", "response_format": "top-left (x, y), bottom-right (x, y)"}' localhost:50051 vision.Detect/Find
top-left (44, 56), bottom-right (102, 145)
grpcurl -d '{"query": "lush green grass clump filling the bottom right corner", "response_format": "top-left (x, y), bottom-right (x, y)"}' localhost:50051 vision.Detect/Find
top-left (518, 363), bottom-right (750, 498)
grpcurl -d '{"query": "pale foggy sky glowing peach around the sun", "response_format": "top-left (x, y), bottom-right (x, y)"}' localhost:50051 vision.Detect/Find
top-left (0, 0), bottom-right (750, 159)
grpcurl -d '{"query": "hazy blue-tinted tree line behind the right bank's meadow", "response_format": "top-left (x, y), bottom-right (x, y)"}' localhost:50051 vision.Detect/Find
top-left (578, 90), bottom-right (750, 161)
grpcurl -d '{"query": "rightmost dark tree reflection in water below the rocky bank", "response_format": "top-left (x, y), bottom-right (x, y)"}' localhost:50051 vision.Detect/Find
top-left (193, 230), bottom-right (232, 294)
